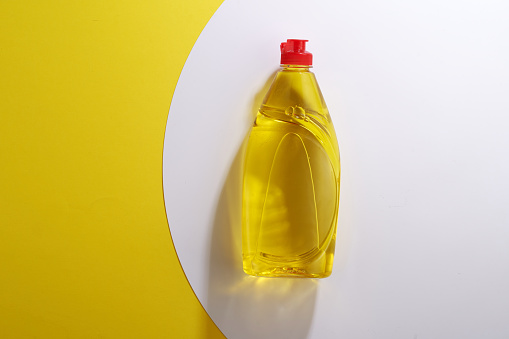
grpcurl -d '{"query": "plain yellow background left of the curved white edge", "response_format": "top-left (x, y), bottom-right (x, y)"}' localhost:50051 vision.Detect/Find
top-left (0, 0), bottom-right (223, 338)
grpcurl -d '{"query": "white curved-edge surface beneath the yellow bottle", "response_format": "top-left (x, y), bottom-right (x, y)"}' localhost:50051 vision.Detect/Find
top-left (164, 0), bottom-right (509, 339)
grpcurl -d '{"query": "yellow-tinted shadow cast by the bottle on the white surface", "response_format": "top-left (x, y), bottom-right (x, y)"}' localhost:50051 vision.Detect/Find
top-left (205, 75), bottom-right (319, 339)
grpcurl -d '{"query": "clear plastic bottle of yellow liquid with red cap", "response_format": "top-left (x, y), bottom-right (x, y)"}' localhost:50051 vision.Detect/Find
top-left (242, 39), bottom-right (340, 278)
